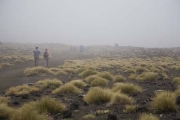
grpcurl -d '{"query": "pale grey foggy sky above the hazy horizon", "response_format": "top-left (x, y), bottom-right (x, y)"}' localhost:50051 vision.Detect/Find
top-left (0, 0), bottom-right (180, 47)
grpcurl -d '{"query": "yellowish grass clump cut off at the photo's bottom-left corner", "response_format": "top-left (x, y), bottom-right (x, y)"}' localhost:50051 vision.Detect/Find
top-left (0, 103), bottom-right (15, 120)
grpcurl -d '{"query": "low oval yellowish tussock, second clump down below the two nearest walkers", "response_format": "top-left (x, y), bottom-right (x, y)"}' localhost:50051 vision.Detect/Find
top-left (36, 79), bottom-right (62, 89)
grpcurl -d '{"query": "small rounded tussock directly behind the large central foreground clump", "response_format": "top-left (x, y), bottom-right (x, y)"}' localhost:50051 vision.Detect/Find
top-left (90, 77), bottom-right (108, 87)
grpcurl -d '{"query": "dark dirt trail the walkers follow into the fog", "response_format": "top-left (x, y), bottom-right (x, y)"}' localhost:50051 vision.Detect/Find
top-left (0, 53), bottom-right (92, 93)
